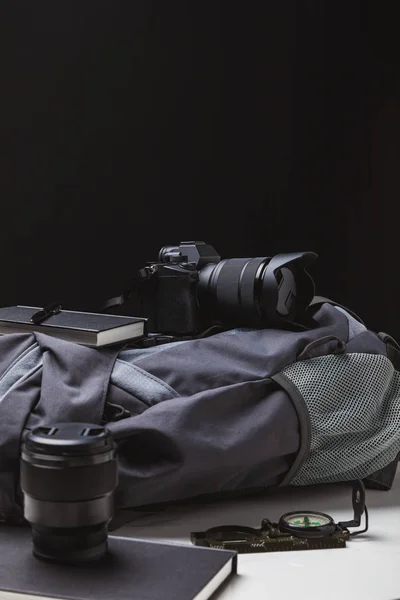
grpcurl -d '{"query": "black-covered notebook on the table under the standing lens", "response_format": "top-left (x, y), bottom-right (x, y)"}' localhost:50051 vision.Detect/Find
top-left (0, 525), bottom-right (236, 600)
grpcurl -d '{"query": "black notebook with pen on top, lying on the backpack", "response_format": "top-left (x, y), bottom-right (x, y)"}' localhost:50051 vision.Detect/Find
top-left (0, 306), bottom-right (146, 347)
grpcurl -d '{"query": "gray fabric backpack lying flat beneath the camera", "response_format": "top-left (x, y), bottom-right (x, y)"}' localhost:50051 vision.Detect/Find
top-left (0, 298), bottom-right (400, 521)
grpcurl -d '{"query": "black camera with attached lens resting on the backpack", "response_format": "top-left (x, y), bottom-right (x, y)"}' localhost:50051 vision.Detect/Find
top-left (126, 241), bottom-right (317, 336)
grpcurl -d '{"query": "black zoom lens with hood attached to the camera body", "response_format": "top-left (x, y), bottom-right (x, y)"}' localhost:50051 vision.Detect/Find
top-left (198, 252), bottom-right (317, 327)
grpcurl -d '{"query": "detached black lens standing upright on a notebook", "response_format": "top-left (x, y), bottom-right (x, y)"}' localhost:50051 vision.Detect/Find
top-left (21, 423), bottom-right (118, 563)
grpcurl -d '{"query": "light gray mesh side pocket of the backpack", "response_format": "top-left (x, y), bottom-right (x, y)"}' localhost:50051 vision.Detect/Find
top-left (282, 354), bottom-right (400, 485)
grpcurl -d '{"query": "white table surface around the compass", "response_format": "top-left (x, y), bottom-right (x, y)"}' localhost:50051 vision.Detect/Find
top-left (111, 471), bottom-right (400, 600)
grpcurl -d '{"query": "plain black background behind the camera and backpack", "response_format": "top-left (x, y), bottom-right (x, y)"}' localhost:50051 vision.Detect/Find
top-left (0, 0), bottom-right (400, 336)
